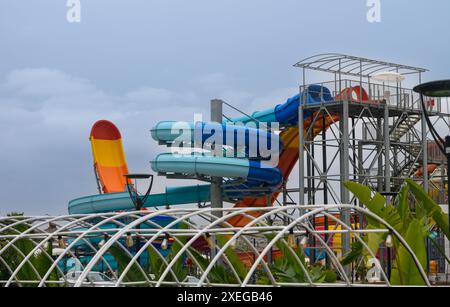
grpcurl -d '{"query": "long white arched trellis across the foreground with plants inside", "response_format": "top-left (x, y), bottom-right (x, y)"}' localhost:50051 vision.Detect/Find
top-left (0, 205), bottom-right (430, 287)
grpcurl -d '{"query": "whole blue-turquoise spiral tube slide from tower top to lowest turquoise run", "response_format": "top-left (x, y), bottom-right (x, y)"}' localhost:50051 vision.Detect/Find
top-left (69, 85), bottom-right (334, 214)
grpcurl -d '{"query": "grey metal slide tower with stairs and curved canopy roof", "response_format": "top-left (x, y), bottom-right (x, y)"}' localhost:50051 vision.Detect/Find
top-left (294, 54), bottom-right (449, 262)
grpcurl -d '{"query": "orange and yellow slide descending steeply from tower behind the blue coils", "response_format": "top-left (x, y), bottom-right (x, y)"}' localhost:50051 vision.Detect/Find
top-left (228, 113), bottom-right (339, 227)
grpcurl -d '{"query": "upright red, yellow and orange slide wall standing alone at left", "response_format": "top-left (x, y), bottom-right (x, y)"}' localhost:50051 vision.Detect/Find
top-left (89, 120), bottom-right (130, 193)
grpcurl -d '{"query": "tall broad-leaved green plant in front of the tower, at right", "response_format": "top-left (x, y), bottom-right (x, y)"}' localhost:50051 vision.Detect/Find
top-left (342, 180), bottom-right (449, 285)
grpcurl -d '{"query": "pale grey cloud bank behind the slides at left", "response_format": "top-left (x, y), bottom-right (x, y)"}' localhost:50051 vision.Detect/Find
top-left (0, 68), bottom-right (298, 214)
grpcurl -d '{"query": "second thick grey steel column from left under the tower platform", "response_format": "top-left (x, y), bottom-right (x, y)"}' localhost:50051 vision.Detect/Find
top-left (339, 100), bottom-right (351, 273)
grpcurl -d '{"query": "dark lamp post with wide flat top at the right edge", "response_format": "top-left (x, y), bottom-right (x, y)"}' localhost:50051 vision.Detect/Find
top-left (414, 80), bottom-right (450, 238)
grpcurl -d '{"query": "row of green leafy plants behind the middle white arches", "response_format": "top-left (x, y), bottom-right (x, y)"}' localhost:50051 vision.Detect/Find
top-left (112, 230), bottom-right (337, 285)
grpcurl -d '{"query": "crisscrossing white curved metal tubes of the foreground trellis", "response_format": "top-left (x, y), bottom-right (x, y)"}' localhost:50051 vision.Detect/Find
top-left (0, 205), bottom-right (430, 286)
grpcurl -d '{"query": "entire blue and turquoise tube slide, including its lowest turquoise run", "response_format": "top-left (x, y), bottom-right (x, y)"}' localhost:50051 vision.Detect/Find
top-left (69, 85), bottom-right (334, 214)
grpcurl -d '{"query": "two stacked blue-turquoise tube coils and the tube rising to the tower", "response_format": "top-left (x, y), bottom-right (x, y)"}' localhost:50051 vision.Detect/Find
top-left (145, 85), bottom-right (333, 197)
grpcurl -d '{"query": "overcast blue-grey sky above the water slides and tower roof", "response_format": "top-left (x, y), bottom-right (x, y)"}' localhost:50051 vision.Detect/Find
top-left (0, 0), bottom-right (450, 214)
